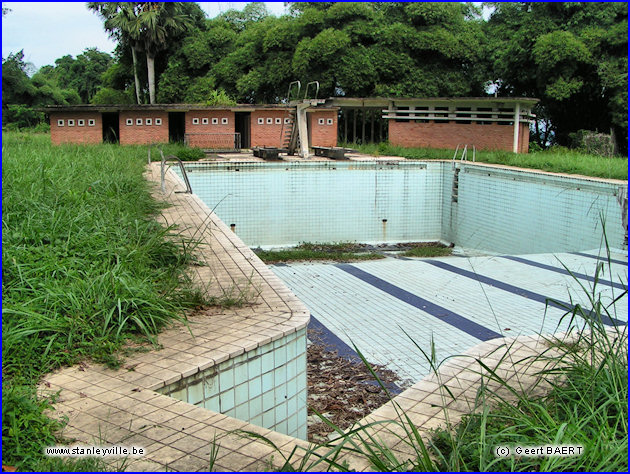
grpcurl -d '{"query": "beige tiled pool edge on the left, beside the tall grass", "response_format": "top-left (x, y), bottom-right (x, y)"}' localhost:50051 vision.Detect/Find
top-left (41, 162), bottom-right (309, 470)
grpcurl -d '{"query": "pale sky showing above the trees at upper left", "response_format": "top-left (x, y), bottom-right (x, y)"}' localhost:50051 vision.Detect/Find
top-left (2, 2), bottom-right (286, 72)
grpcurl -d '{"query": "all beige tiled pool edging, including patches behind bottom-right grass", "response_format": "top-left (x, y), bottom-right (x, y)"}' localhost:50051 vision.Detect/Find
top-left (42, 160), bottom-right (628, 471)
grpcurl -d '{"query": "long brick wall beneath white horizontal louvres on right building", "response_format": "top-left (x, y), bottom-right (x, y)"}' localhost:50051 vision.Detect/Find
top-left (389, 120), bottom-right (529, 153)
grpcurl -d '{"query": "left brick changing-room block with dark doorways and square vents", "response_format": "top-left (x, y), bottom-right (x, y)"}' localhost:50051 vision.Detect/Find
top-left (45, 104), bottom-right (338, 150)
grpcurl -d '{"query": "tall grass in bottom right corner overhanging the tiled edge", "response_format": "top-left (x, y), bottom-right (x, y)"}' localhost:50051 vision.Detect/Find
top-left (245, 237), bottom-right (628, 472)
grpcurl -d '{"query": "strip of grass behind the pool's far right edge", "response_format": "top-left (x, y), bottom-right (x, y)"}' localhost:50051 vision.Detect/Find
top-left (348, 143), bottom-right (628, 180)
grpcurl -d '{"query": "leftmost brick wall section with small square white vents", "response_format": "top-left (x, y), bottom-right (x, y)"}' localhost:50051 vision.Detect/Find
top-left (50, 111), bottom-right (103, 145)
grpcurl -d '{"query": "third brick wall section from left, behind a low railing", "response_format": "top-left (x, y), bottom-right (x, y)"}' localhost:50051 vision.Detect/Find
top-left (186, 110), bottom-right (235, 148)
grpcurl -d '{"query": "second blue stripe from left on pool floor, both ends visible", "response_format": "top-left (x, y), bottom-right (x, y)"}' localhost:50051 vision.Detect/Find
top-left (335, 263), bottom-right (503, 341)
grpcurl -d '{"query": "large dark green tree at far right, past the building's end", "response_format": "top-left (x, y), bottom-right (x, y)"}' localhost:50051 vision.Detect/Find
top-left (486, 2), bottom-right (628, 150)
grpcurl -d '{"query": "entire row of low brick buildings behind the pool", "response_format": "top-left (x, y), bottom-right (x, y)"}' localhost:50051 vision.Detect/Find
top-left (46, 97), bottom-right (538, 153)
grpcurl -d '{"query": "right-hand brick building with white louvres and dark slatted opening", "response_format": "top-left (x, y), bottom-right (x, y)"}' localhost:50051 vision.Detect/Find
top-left (327, 97), bottom-right (538, 153)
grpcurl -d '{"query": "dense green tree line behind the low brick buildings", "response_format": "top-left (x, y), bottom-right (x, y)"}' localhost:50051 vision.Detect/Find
top-left (2, 2), bottom-right (628, 153)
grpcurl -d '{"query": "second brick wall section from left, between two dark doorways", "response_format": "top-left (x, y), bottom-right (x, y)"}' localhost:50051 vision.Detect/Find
top-left (119, 110), bottom-right (168, 145)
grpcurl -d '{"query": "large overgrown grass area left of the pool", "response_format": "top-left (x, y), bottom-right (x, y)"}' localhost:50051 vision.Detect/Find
top-left (2, 133), bottom-right (202, 470)
